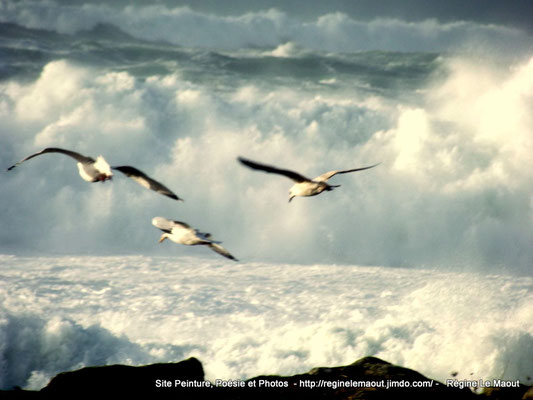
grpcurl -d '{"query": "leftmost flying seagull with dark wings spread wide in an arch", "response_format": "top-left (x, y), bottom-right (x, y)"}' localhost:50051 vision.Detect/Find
top-left (7, 147), bottom-right (182, 200)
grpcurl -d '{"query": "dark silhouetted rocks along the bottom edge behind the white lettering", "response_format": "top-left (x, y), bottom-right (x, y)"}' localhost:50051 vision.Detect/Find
top-left (0, 357), bottom-right (533, 400)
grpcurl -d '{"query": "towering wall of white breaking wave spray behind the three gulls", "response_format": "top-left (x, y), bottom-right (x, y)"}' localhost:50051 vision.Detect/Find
top-left (0, 53), bottom-right (533, 274)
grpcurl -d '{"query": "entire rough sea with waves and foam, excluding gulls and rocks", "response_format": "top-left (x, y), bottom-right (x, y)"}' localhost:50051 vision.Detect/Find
top-left (0, 0), bottom-right (533, 388)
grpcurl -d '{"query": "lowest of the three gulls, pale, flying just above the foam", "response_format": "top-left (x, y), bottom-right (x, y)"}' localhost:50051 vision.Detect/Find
top-left (152, 217), bottom-right (239, 261)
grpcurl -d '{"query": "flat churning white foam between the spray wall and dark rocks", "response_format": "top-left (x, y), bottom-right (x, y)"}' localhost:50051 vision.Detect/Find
top-left (0, 256), bottom-right (533, 388)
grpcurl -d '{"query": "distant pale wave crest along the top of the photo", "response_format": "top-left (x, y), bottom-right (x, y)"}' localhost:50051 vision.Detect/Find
top-left (0, 0), bottom-right (530, 52)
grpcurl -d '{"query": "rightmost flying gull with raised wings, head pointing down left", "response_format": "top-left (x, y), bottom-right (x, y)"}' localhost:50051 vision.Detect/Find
top-left (238, 157), bottom-right (380, 202)
